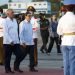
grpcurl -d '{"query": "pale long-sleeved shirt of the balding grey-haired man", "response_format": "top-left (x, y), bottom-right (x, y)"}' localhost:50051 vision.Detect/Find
top-left (3, 17), bottom-right (19, 44)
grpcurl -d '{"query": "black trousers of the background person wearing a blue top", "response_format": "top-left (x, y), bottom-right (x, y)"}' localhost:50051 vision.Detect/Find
top-left (48, 37), bottom-right (61, 53)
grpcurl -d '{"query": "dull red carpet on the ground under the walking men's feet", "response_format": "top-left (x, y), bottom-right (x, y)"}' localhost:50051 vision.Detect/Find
top-left (0, 67), bottom-right (63, 75)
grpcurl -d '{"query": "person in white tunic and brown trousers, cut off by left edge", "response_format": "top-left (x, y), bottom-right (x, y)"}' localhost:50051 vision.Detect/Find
top-left (0, 8), bottom-right (4, 65)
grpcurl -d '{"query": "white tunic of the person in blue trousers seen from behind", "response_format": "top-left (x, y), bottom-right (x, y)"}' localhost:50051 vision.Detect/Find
top-left (57, 12), bottom-right (75, 46)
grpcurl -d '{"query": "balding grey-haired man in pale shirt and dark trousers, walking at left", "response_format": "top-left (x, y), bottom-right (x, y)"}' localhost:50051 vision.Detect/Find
top-left (3, 9), bottom-right (23, 73)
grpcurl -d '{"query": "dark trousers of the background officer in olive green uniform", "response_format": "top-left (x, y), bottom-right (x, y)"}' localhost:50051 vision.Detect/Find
top-left (41, 30), bottom-right (49, 51)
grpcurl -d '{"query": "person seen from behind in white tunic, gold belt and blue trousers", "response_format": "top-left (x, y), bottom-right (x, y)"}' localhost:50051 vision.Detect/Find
top-left (57, 4), bottom-right (75, 75)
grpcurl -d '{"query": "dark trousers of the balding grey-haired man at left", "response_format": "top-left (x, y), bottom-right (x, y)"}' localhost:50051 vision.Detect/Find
top-left (4, 44), bottom-right (22, 71)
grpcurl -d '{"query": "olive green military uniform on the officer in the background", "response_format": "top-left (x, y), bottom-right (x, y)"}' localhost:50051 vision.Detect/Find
top-left (40, 15), bottom-right (49, 53)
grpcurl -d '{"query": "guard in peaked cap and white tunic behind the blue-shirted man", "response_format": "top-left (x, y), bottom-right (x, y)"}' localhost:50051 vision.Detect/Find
top-left (27, 6), bottom-right (38, 66)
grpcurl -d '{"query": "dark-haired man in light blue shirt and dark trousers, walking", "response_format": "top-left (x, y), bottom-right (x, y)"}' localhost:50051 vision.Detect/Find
top-left (20, 12), bottom-right (37, 72)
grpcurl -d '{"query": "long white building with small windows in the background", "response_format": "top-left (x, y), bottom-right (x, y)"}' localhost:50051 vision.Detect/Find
top-left (8, 1), bottom-right (51, 14)
